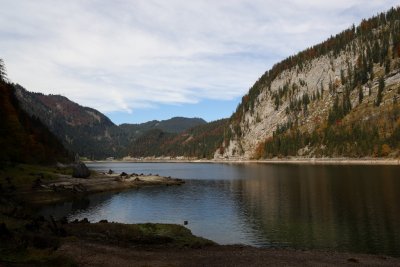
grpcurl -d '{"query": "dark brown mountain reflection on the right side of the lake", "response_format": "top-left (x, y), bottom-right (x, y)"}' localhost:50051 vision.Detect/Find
top-left (233, 165), bottom-right (400, 256)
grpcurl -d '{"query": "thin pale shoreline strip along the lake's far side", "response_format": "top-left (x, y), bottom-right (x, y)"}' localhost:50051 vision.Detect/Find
top-left (84, 158), bottom-right (400, 165)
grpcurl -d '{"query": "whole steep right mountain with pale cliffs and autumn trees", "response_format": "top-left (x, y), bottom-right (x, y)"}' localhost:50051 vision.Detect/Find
top-left (219, 7), bottom-right (400, 158)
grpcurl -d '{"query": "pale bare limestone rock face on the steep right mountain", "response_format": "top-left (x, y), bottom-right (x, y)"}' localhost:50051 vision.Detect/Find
top-left (219, 53), bottom-right (356, 159)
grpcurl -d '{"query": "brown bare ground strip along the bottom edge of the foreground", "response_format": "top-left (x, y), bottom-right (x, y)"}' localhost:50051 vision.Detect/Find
top-left (57, 241), bottom-right (400, 267)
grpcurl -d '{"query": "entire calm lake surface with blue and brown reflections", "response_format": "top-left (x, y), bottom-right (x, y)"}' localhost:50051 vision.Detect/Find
top-left (42, 163), bottom-right (400, 257)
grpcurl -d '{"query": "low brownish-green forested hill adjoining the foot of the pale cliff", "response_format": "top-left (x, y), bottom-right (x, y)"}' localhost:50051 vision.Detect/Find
top-left (128, 119), bottom-right (228, 158)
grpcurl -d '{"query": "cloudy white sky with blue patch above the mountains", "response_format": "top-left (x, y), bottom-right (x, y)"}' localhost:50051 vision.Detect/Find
top-left (0, 0), bottom-right (398, 124)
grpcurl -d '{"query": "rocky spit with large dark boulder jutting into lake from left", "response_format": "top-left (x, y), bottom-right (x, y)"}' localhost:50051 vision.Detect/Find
top-left (0, 164), bottom-right (185, 206)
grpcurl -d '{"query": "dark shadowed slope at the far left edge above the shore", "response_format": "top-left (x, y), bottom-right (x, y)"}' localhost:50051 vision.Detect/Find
top-left (0, 71), bottom-right (71, 165)
